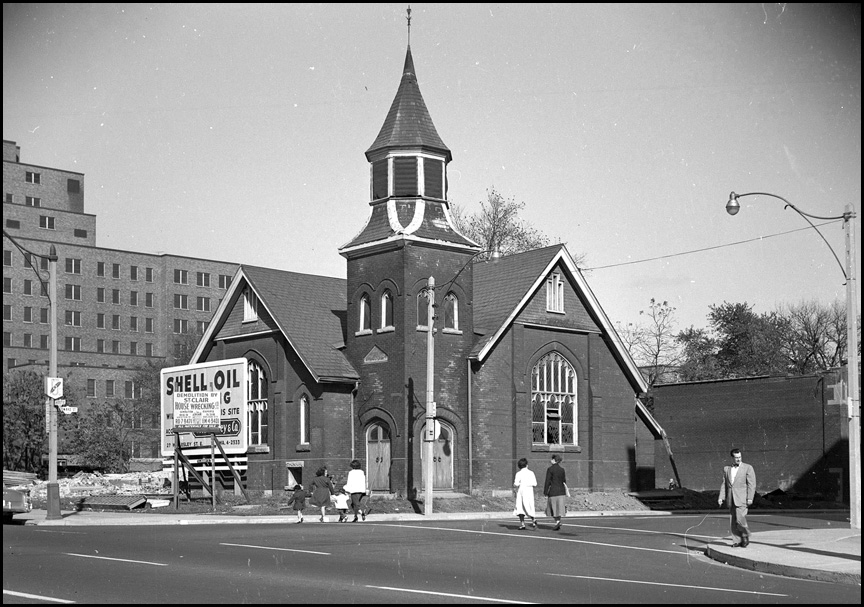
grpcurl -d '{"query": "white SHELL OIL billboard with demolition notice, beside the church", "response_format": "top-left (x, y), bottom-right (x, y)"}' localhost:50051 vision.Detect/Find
top-left (160, 358), bottom-right (249, 457)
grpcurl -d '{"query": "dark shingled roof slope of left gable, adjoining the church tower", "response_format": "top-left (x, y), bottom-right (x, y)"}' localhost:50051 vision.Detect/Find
top-left (242, 265), bottom-right (360, 380)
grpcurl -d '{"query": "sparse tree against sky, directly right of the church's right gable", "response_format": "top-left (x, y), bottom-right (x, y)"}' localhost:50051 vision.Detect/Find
top-left (618, 297), bottom-right (682, 386)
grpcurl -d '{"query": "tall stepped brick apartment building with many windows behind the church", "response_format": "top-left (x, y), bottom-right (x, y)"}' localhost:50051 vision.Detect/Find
top-left (3, 140), bottom-right (239, 457)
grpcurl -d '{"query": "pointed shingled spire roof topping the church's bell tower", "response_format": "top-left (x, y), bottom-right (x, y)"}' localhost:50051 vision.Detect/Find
top-left (366, 46), bottom-right (452, 162)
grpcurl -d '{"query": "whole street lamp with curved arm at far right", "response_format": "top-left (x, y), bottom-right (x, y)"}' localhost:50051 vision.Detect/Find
top-left (726, 192), bottom-right (861, 529)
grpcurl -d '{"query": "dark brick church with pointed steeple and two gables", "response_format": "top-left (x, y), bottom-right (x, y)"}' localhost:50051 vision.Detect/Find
top-left (191, 40), bottom-right (663, 498)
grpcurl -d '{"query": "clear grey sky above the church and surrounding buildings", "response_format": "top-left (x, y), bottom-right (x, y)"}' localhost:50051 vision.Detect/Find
top-left (3, 3), bottom-right (861, 329)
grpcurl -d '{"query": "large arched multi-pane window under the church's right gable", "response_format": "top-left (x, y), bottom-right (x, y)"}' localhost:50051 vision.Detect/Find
top-left (531, 352), bottom-right (578, 445)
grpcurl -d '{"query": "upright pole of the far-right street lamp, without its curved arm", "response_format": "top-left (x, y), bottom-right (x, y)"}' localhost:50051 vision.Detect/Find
top-left (843, 204), bottom-right (861, 529)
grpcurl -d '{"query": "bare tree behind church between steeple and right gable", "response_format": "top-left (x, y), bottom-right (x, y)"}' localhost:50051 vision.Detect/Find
top-left (450, 186), bottom-right (584, 265)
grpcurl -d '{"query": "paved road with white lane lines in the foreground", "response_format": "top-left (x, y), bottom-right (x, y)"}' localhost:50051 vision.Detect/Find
top-left (3, 515), bottom-right (861, 604)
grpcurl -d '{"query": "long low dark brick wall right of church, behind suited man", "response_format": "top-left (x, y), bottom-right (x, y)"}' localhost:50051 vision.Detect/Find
top-left (653, 373), bottom-right (848, 499)
